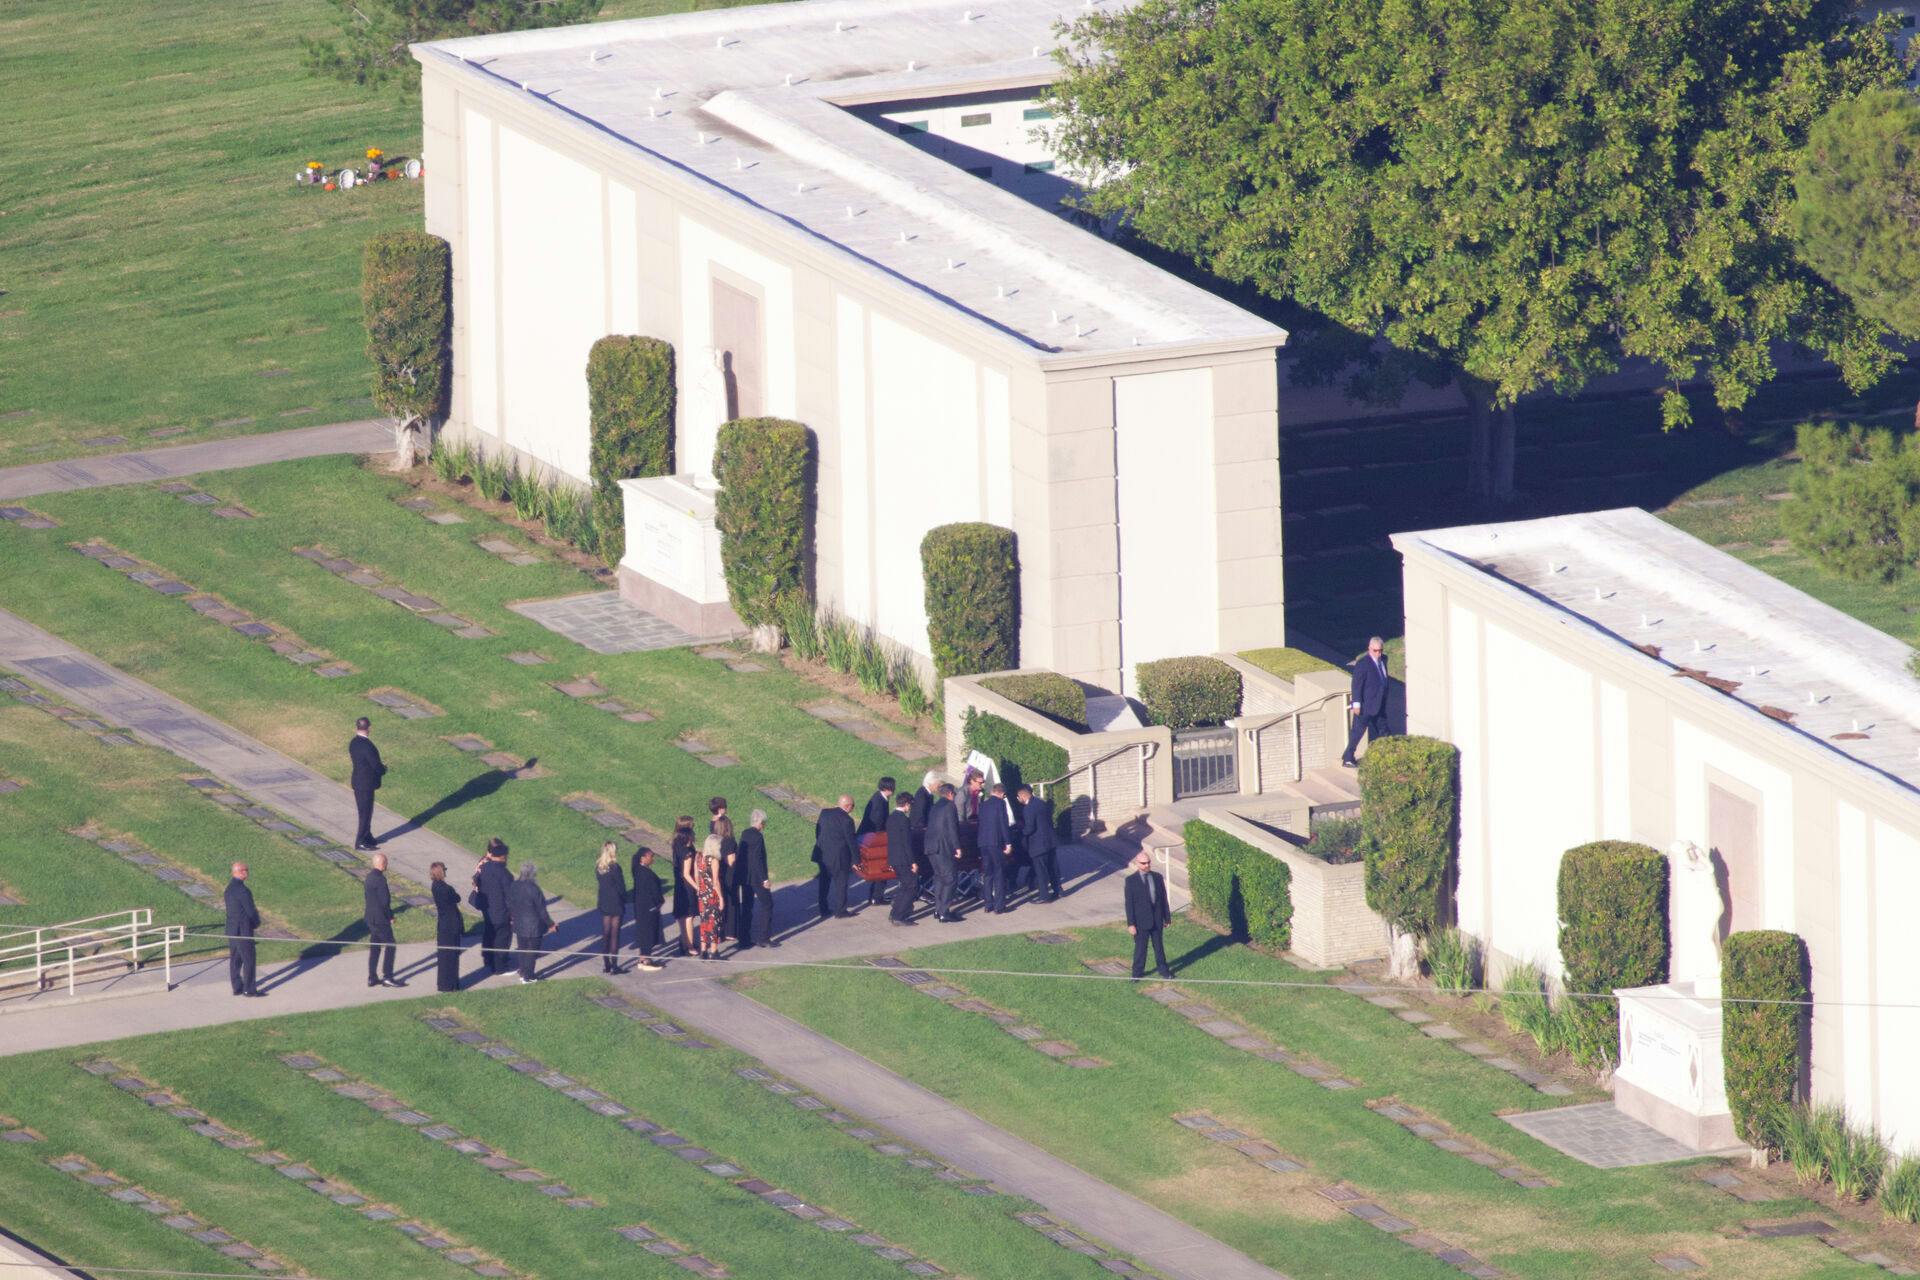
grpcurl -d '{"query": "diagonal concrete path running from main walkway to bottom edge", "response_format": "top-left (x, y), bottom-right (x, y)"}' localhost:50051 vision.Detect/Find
top-left (641, 974), bottom-right (1284, 1280)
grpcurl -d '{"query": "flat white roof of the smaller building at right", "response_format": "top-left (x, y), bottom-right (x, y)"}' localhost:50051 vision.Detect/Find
top-left (1392, 507), bottom-right (1920, 791)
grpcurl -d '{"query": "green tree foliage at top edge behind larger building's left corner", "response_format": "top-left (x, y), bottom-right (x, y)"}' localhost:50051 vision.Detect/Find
top-left (301, 0), bottom-right (601, 92)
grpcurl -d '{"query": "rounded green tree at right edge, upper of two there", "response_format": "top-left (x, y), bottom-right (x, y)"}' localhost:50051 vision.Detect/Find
top-left (1793, 88), bottom-right (1920, 426)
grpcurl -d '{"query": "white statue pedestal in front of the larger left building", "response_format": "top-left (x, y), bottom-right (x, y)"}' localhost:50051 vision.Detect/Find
top-left (616, 476), bottom-right (747, 637)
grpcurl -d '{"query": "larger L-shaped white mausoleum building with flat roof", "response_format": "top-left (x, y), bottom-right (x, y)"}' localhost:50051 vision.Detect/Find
top-left (415, 0), bottom-right (1286, 687)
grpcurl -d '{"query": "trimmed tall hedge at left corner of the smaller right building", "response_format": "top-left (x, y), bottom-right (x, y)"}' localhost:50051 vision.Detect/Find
top-left (1359, 735), bottom-right (1459, 938)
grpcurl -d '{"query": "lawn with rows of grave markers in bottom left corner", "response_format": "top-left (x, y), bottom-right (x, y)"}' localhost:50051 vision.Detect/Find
top-left (0, 981), bottom-right (1106, 1280)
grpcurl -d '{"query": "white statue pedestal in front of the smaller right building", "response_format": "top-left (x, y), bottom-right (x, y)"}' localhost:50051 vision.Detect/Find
top-left (1613, 983), bottom-right (1743, 1151)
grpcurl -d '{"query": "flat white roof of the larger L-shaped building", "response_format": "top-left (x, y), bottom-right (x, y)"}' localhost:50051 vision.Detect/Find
top-left (413, 0), bottom-right (1286, 359)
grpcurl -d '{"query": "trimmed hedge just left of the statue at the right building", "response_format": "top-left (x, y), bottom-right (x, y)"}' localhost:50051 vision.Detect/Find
top-left (1559, 841), bottom-right (1668, 1067)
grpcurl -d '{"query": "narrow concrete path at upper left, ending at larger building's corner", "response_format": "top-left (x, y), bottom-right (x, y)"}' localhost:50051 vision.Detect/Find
top-left (0, 418), bottom-right (394, 499)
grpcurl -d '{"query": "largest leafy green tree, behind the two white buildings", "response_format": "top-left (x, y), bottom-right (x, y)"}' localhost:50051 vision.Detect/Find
top-left (1056, 0), bottom-right (1901, 499)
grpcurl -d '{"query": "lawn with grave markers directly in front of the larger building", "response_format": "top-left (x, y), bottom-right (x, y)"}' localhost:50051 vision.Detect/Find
top-left (0, 459), bottom-right (929, 906)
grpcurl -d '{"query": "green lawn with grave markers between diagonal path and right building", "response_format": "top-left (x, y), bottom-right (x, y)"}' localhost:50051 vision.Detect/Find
top-left (735, 921), bottom-right (1859, 1280)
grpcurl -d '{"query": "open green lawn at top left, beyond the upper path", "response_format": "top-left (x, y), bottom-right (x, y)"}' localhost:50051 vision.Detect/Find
top-left (0, 0), bottom-right (756, 466)
